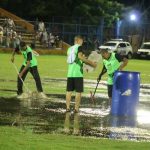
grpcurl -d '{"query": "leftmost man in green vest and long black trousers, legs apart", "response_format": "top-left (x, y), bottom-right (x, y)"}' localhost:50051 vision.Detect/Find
top-left (11, 41), bottom-right (47, 98)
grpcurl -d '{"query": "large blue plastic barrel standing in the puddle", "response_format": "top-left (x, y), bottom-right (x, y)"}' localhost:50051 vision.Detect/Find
top-left (111, 71), bottom-right (140, 116)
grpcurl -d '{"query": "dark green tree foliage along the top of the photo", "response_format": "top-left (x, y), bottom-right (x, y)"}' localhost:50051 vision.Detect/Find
top-left (0, 0), bottom-right (123, 25)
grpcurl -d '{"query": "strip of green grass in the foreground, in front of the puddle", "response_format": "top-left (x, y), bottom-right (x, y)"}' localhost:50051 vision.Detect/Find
top-left (0, 127), bottom-right (150, 150)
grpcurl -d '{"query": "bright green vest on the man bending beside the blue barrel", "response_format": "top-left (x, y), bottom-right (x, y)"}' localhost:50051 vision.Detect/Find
top-left (103, 53), bottom-right (121, 85)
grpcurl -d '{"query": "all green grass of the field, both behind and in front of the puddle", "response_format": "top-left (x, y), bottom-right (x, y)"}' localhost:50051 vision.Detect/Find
top-left (0, 54), bottom-right (150, 150)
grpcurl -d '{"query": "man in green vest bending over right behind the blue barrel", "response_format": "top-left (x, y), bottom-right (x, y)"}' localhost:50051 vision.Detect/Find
top-left (98, 49), bottom-right (128, 102)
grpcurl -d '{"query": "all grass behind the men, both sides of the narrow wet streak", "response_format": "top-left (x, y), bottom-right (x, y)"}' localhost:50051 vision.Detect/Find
top-left (0, 54), bottom-right (150, 96)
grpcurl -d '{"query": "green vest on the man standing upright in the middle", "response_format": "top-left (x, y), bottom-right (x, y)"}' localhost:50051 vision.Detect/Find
top-left (67, 44), bottom-right (83, 78)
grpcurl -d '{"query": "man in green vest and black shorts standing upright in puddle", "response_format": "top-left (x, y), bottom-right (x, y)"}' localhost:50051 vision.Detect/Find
top-left (66, 35), bottom-right (96, 113)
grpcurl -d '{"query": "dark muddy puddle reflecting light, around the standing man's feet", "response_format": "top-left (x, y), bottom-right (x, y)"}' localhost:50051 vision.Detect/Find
top-left (0, 95), bottom-right (150, 141)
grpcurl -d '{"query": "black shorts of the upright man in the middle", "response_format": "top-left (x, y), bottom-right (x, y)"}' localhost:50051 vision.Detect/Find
top-left (67, 77), bottom-right (83, 93)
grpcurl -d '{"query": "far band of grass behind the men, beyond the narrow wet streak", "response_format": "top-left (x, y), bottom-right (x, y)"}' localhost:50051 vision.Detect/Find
top-left (0, 54), bottom-right (150, 83)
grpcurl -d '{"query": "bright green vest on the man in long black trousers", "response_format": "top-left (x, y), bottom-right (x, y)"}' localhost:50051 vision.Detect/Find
top-left (21, 46), bottom-right (37, 67)
